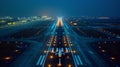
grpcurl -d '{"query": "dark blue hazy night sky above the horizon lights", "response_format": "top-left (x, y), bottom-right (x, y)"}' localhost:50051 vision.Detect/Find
top-left (0, 0), bottom-right (120, 17)
